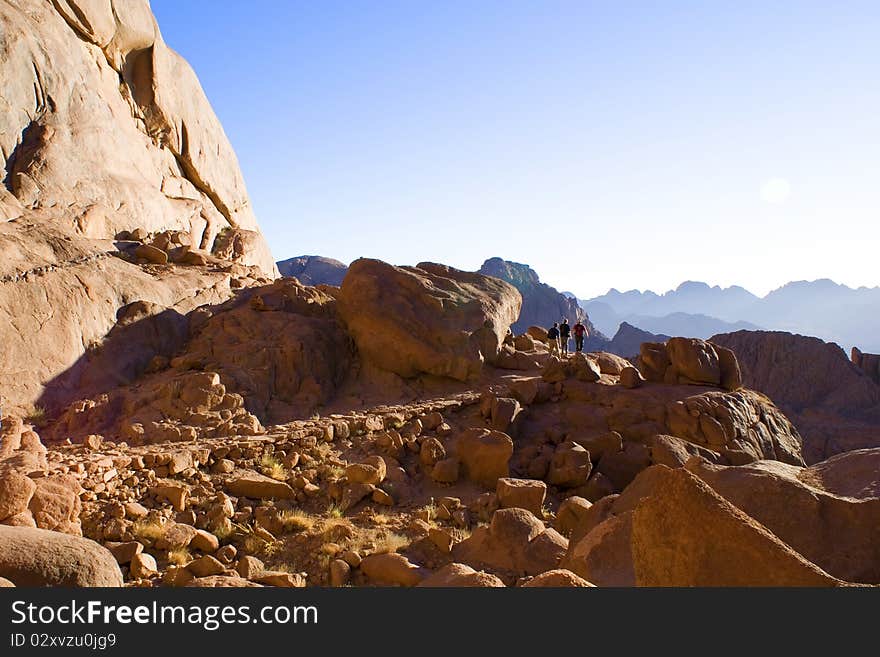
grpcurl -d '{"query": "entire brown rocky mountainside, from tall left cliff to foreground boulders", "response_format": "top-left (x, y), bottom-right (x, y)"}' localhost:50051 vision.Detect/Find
top-left (0, 0), bottom-right (880, 588)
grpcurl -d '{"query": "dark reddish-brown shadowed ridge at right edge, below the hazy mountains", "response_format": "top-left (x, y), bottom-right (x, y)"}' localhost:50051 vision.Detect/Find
top-left (711, 331), bottom-right (880, 463)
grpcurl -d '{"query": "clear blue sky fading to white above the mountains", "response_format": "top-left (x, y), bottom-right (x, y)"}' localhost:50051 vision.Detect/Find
top-left (152, 0), bottom-right (880, 298)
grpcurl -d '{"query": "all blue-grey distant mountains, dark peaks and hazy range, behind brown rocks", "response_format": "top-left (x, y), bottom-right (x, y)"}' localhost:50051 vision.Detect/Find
top-left (278, 256), bottom-right (880, 356)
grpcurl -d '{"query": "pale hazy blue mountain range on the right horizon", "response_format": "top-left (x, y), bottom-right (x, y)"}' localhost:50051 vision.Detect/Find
top-left (579, 279), bottom-right (880, 352)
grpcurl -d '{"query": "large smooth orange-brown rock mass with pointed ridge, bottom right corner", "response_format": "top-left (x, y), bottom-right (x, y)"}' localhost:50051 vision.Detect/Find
top-left (562, 459), bottom-right (876, 586)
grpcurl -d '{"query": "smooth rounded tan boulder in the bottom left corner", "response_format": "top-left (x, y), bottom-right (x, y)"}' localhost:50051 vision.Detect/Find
top-left (0, 526), bottom-right (122, 587)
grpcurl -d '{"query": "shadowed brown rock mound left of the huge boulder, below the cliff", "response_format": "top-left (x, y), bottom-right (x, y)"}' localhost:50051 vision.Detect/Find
top-left (40, 280), bottom-right (353, 444)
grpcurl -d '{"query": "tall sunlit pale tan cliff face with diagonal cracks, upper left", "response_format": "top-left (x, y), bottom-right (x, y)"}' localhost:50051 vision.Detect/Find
top-left (0, 0), bottom-right (275, 274)
